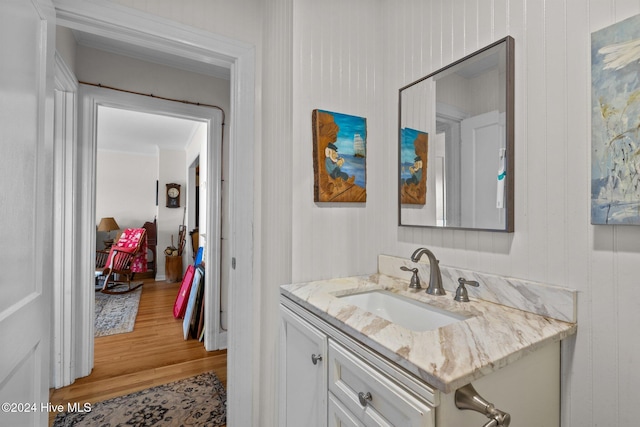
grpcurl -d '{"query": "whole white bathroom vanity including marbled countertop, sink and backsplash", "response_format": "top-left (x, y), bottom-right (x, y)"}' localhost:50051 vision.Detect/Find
top-left (280, 256), bottom-right (576, 427)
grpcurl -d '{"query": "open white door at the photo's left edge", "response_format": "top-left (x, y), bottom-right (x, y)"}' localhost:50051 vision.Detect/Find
top-left (0, 0), bottom-right (55, 426)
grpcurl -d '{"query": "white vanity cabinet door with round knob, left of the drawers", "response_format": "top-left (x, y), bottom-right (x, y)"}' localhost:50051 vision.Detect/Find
top-left (280, 306), bottom-right (327, 427)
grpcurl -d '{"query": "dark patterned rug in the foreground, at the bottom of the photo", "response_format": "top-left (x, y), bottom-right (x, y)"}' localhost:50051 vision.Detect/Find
top-left (53, 372), bottom-right (227, 427)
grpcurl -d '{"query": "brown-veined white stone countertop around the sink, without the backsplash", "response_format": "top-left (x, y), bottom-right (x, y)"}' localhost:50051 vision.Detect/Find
top-left (280, 273), bottom-right (577, 393)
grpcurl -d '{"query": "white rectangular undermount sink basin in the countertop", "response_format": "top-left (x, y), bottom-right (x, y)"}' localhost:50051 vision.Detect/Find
top-left (338, 290), bottom-right (466, 331)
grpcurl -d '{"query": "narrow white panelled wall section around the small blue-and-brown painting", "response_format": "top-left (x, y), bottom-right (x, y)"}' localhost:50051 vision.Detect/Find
top-left (292, 0), bottom-right (388, 281)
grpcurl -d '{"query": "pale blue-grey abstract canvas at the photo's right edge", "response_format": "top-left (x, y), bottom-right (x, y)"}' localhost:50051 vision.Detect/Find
top-left (591, 15), bottom-right (640, 224)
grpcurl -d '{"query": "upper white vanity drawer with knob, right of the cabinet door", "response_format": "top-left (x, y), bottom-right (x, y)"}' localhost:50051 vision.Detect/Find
top-left (329, 339), bottom-right (434, 427)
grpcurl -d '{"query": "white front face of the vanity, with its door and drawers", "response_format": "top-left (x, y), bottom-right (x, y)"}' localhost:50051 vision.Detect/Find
top-left (280, 304), bottom-right (435, 427)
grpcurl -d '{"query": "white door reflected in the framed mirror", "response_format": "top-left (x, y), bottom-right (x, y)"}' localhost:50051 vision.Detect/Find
top-left (460, 111), bottom-right (506, 229)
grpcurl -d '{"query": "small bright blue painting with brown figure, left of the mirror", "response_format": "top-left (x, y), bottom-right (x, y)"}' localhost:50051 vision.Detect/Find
top-left (311, 110), bottom-right (367, 202)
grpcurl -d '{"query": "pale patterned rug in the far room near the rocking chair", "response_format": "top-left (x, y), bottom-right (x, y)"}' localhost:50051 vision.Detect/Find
top-left (94, 285), bottom-right (142, 337)
